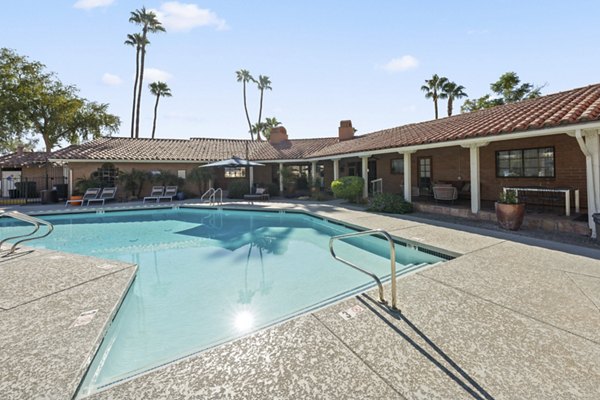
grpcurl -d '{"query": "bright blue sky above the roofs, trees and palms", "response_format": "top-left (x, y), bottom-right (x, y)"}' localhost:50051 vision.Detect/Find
top-left (0, 0), bottom-right (600, 144)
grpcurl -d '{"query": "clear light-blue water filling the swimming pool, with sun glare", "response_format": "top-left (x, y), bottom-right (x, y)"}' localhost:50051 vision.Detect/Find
top-left (2, 208), bottom-right (443, 394)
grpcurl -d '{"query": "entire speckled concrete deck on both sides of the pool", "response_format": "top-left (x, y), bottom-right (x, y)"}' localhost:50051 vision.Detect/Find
top-left (0, 202), bottom-right (600, 399)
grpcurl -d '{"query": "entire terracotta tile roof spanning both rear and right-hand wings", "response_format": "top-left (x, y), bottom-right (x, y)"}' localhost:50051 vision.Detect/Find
top-left (51, 84), bottom-right (600, 162)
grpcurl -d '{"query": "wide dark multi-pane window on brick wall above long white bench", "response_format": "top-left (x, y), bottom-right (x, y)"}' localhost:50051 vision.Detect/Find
top-left (496, 147), bottom-right (555, 178)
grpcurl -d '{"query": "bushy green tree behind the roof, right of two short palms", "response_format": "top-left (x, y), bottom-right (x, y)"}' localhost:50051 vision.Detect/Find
top-left (461, 72), bottom-right (543, 112)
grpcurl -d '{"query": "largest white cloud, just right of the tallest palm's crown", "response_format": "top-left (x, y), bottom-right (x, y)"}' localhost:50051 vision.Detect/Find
top-left (152, 1), bottom-right (228, 31)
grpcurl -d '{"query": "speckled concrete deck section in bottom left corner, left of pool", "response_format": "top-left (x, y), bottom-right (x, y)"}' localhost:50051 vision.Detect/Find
top-left (0, 248), bottom-right (136, 399)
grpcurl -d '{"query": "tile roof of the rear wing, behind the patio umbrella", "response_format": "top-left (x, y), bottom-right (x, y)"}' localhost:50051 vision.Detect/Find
top-left (51, 137), bottom-right (338, 162)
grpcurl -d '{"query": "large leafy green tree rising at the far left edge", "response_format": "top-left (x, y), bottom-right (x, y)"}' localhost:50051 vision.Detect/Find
top-left (0, 48), bottom-right (120, 152)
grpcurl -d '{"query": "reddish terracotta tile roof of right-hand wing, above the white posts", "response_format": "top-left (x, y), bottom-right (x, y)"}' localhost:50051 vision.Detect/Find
top-left (312, 84), bottom-right (600, 157)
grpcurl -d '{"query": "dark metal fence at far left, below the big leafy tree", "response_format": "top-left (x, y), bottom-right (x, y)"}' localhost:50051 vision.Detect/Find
top-left (0, 174), bottom-right (69, 205)
